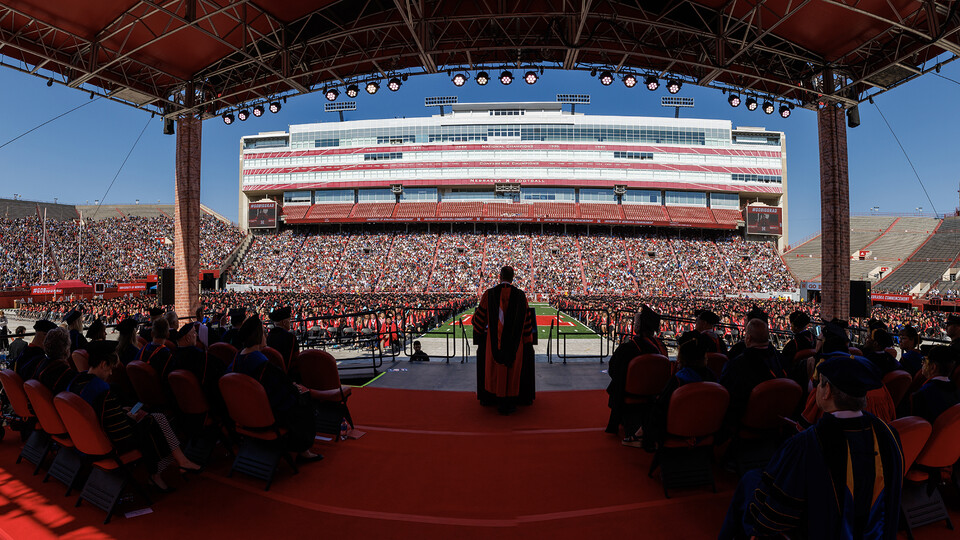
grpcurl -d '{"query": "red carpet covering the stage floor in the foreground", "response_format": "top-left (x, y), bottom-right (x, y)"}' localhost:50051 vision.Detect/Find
top-left (0, 388), bottom-right (957, 540)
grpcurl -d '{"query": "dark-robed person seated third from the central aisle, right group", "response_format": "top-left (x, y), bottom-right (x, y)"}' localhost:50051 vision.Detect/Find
top-left (720, 318), bottom-right (787, 428)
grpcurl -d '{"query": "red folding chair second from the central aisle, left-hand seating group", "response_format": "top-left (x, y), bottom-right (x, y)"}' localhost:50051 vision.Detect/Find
top-left (219, 373), bottom-right (299, 491)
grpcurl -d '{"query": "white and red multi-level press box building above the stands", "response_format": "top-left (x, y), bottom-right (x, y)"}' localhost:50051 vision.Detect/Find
top-left (240, 102), bottom-right (787, 248)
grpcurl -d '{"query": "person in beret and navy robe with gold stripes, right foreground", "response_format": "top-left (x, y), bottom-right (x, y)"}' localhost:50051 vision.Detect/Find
top-left (719, 355), bottom-right (903, 540)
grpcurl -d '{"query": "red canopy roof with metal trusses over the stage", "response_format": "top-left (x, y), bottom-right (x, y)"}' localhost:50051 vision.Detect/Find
top-left (0, 0), bottom-right (960, 117)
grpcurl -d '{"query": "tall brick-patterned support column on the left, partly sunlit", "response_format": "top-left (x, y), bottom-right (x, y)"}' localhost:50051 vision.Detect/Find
top-left (173, 114), bottom-right (201, 317)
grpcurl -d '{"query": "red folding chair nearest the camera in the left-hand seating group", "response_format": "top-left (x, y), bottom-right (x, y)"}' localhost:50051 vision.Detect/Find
top-left (53, 392), bottom-right (152, 525)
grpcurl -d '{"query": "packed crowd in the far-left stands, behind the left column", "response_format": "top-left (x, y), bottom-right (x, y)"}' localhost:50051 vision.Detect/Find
top-left (0, 214), bottom-right (244, 288)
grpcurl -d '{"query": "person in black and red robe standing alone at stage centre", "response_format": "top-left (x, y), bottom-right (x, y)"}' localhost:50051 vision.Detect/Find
top-left (472, 266), bottom-right (534, 414)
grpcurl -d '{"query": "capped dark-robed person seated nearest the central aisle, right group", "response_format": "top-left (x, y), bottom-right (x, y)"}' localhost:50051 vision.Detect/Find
top-left (606, 306), bottom-right (667, 443)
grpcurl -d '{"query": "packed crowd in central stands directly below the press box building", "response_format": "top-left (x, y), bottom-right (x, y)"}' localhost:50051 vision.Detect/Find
top-left (228, 228), bottom-right (797, 297)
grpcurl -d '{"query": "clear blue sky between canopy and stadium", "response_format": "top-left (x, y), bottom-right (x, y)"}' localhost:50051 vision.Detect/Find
top-left (0, 62), bottom-right (960, 243)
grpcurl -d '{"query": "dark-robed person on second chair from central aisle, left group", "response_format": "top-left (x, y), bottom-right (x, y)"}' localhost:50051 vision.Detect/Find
top-left (226, 315), bottom-right (323, 461)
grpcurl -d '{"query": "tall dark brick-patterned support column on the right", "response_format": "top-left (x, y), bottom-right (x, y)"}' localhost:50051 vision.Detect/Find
top-left (817, 70), bottom-right (850, 321)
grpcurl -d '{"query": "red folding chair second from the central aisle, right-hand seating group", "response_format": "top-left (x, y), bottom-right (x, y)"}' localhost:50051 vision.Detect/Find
top-left (648, 382), bottom-right (730, 498)
